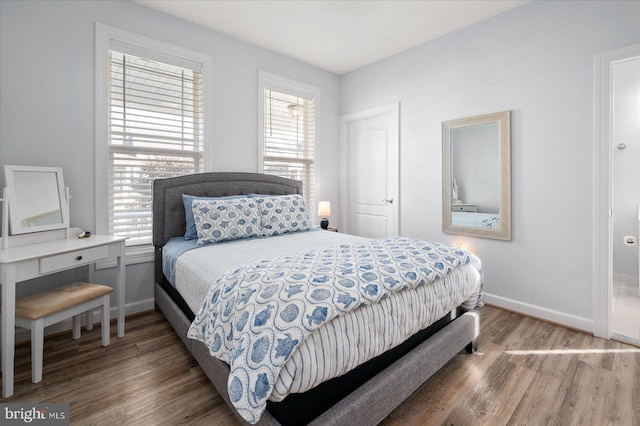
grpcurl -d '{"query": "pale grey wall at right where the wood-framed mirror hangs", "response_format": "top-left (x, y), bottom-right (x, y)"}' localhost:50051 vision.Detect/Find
top-left (340, 1), bottom-right (640, 330)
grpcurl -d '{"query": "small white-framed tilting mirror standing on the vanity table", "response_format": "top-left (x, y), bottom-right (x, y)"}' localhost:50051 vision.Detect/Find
top-left (3, 166), bottom-right (69, 236)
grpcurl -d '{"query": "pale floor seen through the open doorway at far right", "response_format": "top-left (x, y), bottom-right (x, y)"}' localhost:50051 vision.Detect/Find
top-left (613, 281), bottom-right (640, 346)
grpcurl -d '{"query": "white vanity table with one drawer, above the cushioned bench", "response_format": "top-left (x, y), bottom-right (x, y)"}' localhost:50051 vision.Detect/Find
top-left (0, 234), bottom-right (125, 398)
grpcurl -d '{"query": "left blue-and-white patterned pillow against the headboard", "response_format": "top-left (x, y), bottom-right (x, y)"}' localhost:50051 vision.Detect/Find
top-left (192, 198), bottom-right (262, 244)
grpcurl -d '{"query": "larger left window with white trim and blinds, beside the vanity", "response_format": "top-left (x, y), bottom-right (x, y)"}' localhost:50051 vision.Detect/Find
top-left (96, 24), bottom-right (212, 263)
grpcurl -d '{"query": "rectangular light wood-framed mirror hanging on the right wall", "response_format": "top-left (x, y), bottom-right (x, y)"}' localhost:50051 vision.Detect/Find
top-left (442, 111), bottom-right (511, 240)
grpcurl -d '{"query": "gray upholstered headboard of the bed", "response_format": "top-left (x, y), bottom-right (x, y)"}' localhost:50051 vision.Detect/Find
top-left (153, 172), bottom-right (302, 282)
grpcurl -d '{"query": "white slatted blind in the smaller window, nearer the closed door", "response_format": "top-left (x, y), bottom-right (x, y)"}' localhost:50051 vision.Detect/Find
top-left (264, 88), bottom-right (316, 213)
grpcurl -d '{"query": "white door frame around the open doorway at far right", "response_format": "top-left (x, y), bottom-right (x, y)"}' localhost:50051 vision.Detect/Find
top-left (592, 44), bottom-right (640, 339)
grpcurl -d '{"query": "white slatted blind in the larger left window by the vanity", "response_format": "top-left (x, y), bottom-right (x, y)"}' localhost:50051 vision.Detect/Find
top-left (108, 50), bottom-right (204, 245)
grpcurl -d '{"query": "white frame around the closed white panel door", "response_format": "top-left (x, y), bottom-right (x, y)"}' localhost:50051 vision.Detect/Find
top-left (340, 103), bottom-right (400, 235)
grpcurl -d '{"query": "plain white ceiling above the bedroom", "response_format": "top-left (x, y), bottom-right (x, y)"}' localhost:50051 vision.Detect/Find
top-left (133, 0), bottom-right (529, 74)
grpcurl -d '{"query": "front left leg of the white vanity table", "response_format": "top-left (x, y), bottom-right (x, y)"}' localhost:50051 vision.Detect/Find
top-left (0, 263), bottom-right (16, 398)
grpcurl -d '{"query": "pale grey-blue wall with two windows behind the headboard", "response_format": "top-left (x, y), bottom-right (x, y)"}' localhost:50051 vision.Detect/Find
top-left (0, 0), bottom-right (339, 312)
